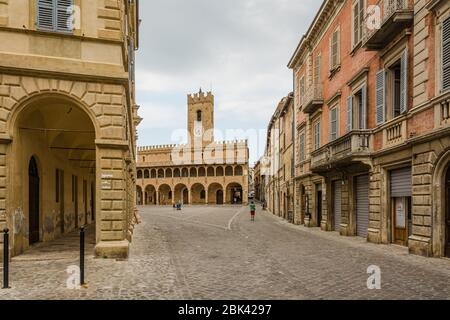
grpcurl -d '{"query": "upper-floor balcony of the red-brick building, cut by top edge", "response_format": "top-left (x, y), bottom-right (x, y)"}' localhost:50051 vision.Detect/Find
top-left (362, 0), bottom-right (414, 50)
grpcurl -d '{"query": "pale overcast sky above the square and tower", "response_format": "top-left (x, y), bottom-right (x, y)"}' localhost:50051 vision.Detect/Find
top-left (136, 0), bottom-right (322, 165)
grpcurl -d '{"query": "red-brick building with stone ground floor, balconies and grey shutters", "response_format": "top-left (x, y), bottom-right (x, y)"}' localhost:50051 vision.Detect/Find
top-left (260, 0), bottom-right (450, 257)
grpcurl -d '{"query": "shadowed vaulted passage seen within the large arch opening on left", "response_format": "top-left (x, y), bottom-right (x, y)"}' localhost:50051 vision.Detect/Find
top-left (7, 93), bottom-right (96, 255)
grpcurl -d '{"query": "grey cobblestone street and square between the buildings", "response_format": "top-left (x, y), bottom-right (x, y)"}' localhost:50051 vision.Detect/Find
top-left (0, 206), bottom-right (450, 299)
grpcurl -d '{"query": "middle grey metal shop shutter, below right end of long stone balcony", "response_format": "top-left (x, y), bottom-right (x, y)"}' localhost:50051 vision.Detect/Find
top-left (356, 175), bottom-right (369, 237)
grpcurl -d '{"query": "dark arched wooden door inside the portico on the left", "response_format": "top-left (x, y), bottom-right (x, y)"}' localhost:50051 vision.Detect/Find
top-left (28, 157), bottom-right (39, 245)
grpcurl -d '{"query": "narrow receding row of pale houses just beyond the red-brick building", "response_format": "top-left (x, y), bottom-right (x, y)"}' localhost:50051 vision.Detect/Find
top-left (264, 93), bottom-right (295, 221)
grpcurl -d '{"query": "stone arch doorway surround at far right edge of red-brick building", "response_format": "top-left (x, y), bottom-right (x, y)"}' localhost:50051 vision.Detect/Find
top-left (430, 150), bottom-right (450, 257)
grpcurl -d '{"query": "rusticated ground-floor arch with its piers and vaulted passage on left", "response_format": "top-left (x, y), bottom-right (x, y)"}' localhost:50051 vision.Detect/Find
top-left (0, 87), bottom-right (134, 258)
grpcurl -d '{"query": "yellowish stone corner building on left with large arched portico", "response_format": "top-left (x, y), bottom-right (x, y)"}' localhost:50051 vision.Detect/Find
top-left (0, 0), bottom-right (140, 258)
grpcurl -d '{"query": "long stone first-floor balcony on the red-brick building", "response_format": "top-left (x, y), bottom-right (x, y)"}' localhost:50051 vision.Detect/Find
top-left (311, 130), bottom-right (372, 172)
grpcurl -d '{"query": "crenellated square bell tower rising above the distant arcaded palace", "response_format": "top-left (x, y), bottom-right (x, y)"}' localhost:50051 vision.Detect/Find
top-left (188, 89), bottom-right (214, 147)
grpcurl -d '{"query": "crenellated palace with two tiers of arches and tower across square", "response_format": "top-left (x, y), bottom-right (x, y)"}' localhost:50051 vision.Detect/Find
top-left (136, 90), bottom-right (249, 205)
